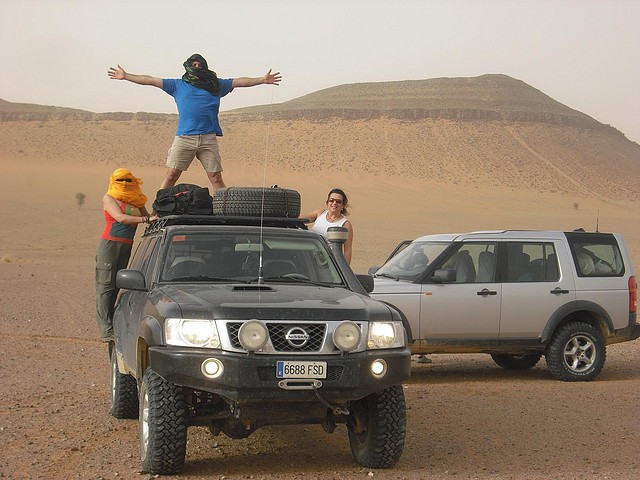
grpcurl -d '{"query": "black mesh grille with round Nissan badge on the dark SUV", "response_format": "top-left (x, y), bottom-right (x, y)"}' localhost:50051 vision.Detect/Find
top-left (227, 322), bottom-right (326, 353)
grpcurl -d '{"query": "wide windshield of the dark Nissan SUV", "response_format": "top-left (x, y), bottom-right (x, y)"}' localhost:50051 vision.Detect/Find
top-left (160, 230), bottom-right (343, 285)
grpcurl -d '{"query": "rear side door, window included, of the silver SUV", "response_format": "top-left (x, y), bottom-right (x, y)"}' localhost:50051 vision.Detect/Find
top-left (500, 240), bottom-right (576, 345)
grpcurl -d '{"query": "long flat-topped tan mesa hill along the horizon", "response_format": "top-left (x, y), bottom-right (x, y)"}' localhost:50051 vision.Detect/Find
top-left (0, 75), bottom-right (640, 200)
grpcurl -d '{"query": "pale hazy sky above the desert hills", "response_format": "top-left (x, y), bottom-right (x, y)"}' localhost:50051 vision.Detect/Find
top-left (0, 0), bottom-right (640, 143)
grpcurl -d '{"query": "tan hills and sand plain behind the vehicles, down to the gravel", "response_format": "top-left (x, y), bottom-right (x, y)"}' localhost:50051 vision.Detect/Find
top-left (0, 75), bottom-right (640, 272)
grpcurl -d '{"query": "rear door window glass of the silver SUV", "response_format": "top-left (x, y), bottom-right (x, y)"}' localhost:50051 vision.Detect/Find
top-left (505, 242), bottom-right (560, 282)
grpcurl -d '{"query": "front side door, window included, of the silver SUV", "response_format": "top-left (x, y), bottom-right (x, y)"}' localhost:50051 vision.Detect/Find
top-left (414, 241), bottom-right (502, 351)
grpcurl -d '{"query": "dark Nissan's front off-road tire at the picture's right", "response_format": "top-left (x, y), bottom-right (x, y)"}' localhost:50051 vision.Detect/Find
top-left (347, 385), bottom-right (407, 468)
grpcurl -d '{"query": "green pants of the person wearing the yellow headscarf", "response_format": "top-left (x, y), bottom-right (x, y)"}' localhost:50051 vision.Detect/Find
top-left (96, 238), bottom-right (131, 339)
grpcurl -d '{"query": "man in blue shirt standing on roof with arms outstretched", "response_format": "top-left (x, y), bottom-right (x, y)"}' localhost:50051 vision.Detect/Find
top-left (108, 53), bottom-right (282, 191)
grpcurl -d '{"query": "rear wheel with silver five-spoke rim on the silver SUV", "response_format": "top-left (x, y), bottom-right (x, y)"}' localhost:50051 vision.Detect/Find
top-left (545, 322), bottom-right (607, 382)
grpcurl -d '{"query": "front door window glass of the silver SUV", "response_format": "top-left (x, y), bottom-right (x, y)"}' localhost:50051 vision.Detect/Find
top-left (440, 242), bottom-right (497, 283)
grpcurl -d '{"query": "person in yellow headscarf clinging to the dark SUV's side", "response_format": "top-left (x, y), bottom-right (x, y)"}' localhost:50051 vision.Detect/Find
top-left (96, 168), bottom-right (158, 342)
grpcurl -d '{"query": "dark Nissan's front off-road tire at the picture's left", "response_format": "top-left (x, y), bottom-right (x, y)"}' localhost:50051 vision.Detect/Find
top-left (139, 369), bottom-right (188, 475)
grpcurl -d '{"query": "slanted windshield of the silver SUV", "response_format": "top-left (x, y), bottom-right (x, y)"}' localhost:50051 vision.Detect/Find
top-left (376, 242), bottom-right (449, 280)
